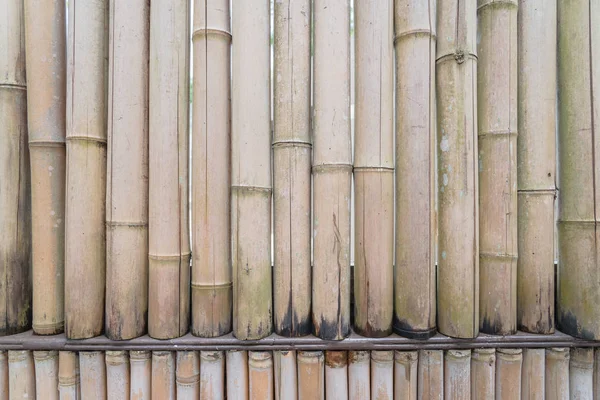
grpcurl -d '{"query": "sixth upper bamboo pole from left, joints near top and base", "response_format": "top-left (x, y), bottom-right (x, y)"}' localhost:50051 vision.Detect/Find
top-left (192, 0), bottom-right (232, 337)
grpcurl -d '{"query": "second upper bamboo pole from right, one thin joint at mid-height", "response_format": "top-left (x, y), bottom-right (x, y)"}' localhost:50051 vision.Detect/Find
top-left (517, 0), bottom-right (557, 333)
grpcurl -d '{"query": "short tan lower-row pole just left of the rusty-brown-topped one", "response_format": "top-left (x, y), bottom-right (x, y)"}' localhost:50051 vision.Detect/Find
top-left (297, 351), bottom-right (325, 400)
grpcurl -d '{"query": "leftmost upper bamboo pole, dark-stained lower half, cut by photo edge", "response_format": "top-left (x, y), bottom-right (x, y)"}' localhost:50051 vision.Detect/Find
top-left (0, 0), bottom-right (31, 335)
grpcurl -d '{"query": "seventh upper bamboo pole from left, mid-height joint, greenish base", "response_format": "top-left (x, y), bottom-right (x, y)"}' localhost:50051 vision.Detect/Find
top-left (231, 0), bottom-right (273, 340)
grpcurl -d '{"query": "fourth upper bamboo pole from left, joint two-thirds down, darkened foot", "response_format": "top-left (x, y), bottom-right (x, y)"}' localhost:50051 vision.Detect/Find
top-left (105, 0), bottom-right (150, 340)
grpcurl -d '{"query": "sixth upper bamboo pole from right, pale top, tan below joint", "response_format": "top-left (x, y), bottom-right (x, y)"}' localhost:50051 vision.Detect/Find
top-left (354, 0), bottom-right (394, 337)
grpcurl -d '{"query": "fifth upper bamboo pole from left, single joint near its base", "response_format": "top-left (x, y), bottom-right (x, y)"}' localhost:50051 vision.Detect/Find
top-left (148, 0), bottom-right (190, 339)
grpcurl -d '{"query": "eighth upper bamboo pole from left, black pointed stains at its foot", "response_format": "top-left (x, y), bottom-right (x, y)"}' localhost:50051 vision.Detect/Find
top-left (272, 0), bottom-right (312, 336)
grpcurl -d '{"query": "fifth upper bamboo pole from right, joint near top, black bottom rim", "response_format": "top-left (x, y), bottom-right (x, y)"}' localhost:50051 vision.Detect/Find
top-left (394, 0), bottom-right (437, 339)
